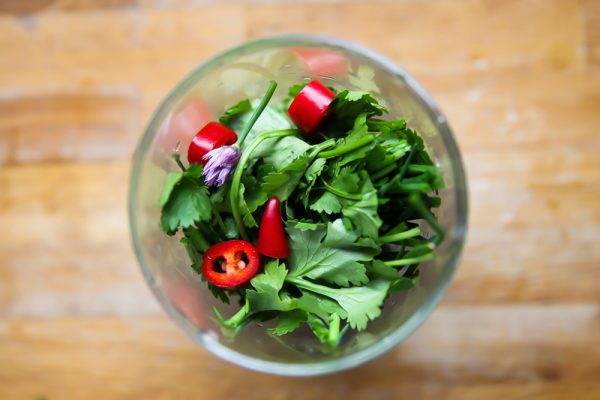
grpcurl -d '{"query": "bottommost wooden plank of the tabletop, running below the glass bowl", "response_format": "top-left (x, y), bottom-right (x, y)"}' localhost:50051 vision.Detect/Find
top-left (0, 305), bottom-right (600, 399)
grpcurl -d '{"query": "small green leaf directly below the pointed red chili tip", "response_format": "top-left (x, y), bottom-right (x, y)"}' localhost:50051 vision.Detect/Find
top-left (246, 260), bottom-right (295, 312)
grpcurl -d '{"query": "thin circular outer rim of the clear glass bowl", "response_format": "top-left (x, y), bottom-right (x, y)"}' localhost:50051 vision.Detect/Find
top-left (128, 34), bottom-right (468, 376)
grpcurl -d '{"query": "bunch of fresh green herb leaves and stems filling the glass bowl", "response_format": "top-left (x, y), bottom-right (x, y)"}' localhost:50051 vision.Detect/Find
top-left (160, 85), bottom-right (444, 347)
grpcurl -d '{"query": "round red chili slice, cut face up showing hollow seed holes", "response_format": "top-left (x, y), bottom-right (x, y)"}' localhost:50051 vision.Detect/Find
top-left (202, 240), bottom-right (260, 289)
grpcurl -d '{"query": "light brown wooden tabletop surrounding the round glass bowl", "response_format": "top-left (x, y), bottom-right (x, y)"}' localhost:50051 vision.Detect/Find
top-left (0, 0), bottom-right (600, 400)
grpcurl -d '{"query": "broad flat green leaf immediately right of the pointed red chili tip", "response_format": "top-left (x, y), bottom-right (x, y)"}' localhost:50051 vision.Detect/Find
top-left (287, 219), bottom-right (376, 287)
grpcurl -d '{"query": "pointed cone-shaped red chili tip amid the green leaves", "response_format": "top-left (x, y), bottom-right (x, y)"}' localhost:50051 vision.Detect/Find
top-left (256, 196), bottom-right (290, 258)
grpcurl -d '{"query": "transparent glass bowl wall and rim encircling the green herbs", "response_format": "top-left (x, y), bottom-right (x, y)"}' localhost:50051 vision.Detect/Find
top-left (129, 35), bottom-right (467, 376)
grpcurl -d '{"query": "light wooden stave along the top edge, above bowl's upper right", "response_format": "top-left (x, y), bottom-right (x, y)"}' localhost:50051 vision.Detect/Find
top-left (247, 0), bottom-right (585, 76)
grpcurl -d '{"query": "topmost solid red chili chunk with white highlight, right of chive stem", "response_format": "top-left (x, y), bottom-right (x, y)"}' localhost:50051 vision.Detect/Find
top-left (288, 80), bottom-right (335, 135)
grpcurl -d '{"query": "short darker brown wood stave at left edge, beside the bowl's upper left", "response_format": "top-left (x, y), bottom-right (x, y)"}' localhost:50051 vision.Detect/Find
top-left (0, 88), bottom-right (141, 164)
